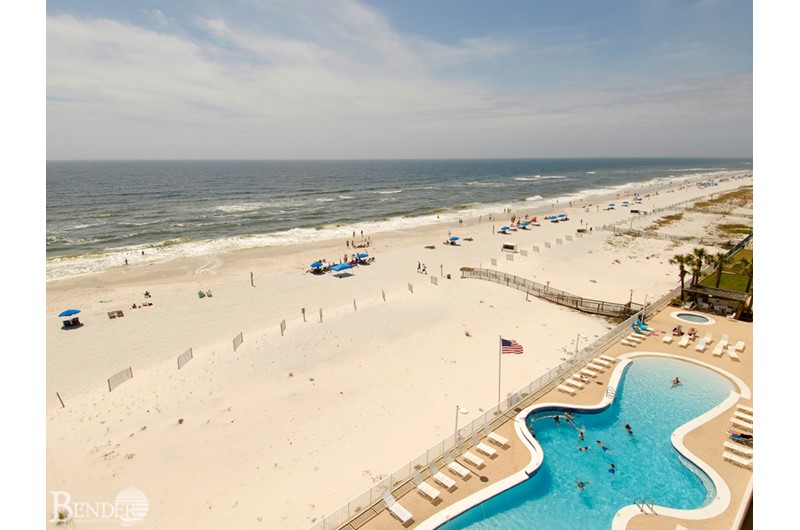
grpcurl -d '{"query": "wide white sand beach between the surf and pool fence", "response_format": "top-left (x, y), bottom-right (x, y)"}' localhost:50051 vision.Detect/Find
top-left (44, 174), bottom-right (752, 529)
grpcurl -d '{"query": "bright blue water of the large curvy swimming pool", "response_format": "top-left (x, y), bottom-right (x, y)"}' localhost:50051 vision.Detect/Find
top-left (439, 357), bottom-right (734, 530)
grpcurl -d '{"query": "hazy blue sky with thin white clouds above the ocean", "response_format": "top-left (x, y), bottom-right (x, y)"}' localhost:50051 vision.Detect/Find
top-left (46, 0), bottom-right (753, 160)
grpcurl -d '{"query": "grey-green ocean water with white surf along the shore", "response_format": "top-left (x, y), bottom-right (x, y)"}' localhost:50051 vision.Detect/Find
top-left (46, 158), bottom-right (752, 280)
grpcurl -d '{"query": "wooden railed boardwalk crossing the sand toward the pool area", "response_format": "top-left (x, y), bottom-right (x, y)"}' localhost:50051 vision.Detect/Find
top-left (461, 267), bottom-right (643, 318)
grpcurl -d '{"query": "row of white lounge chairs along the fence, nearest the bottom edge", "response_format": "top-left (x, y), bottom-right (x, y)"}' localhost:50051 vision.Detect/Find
top-left (383, 432), bottom-right (509, 525)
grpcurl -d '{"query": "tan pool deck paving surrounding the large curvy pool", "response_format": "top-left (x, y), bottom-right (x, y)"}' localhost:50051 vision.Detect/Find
top-left (354, 306), bottom-right (753, 530)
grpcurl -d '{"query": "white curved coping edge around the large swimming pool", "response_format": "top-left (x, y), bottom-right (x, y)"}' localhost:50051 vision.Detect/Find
top-left (416, 351), bottom-right (752, 530)
